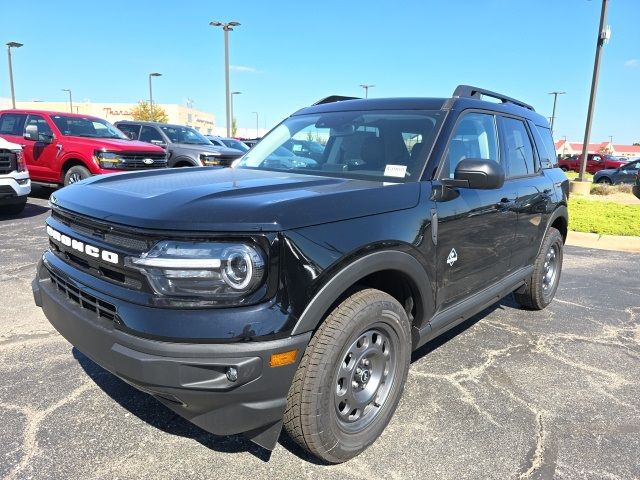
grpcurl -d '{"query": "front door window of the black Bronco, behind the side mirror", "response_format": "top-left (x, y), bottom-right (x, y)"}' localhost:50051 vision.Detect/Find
top-left (440, 113), bottom-right (500, 178)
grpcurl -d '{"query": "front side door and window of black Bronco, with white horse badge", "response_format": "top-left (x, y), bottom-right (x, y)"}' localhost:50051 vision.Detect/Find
top-left (434, 112), bottom-right (517, 310)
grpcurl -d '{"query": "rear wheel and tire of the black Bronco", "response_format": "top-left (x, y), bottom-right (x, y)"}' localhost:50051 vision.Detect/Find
top-left (513, 227), bottom-right (563, 310)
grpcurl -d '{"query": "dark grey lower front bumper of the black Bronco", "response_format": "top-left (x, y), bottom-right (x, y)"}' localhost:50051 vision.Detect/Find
top-left (32, 262), bottom-right (311, 449)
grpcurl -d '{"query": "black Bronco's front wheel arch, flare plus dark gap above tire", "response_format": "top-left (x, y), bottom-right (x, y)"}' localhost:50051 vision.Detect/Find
top-left (291, 250), bottom-right (434, 335)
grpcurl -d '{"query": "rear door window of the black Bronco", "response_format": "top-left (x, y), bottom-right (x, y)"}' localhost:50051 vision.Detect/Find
top-left (500, 117), bottom-right (536, 178)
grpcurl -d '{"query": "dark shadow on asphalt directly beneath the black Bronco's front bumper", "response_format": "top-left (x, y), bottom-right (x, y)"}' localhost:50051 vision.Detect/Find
top-left (72, 347), bottom-right (271, 462)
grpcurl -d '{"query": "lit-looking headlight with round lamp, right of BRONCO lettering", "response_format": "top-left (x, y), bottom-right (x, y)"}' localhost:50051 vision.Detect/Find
top-left (125, 240), bottom-right (265, 301)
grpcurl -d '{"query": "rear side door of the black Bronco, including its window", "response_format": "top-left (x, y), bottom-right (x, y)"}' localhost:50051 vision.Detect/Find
top-left (498, 116), bottom-right (553, 269)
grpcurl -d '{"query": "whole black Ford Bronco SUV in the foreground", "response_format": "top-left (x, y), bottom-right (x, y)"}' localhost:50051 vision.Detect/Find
top-left (33, 86), bottom-right (568, 463)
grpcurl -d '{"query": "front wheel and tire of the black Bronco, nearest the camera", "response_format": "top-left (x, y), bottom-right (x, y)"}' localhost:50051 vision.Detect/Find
top-left (284, 289), bottom-right (411, 463)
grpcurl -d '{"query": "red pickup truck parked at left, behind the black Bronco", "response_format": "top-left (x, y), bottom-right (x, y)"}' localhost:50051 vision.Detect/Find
top-left (0, 110), bottom-right (167, 186)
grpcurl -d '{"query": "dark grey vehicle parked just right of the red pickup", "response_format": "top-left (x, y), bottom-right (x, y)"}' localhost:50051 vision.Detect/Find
top-left (115, 120), bottom-right (243, 167)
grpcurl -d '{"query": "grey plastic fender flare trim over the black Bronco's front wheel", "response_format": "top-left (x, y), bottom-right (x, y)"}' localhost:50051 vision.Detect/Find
top-left (291, 250), bottom-right (434, 335)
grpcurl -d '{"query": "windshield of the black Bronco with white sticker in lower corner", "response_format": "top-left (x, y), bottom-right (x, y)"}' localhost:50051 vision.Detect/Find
top-left (235, 110), bottom-right (445, 181)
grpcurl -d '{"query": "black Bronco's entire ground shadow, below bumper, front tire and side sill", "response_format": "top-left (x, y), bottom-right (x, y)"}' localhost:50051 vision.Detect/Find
top-left (72, 295), bottom-right (518, 465)
